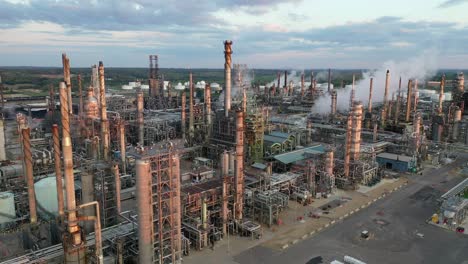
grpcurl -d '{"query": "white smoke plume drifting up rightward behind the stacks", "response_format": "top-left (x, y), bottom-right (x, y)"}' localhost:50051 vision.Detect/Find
top-left (312, 50), bottom-right (437, 114)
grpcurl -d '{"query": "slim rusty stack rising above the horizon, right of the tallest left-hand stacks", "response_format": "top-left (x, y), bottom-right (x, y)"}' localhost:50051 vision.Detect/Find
top-left (99, 61), bottom-right (110, 160)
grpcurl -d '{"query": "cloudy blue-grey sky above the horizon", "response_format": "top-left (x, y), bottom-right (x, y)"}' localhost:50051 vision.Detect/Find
top-left (0, 0), bottom-right (468, 69)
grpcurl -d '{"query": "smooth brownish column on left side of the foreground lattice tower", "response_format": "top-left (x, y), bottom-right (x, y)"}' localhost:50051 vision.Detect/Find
top-left (136, 160), bottom-right (154, 263)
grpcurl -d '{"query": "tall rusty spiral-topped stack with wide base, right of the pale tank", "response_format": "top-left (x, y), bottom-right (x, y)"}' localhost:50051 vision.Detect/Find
top-left (59, 82), bottom-right (85, 263)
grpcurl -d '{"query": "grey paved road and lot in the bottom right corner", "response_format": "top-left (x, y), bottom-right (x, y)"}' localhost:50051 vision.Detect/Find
top-left (234, 154), bottom-right (468, 264)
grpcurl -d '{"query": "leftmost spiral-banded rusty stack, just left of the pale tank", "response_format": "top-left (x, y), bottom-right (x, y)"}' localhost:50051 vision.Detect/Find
top-left (21, 127), bottom-right (37, 224)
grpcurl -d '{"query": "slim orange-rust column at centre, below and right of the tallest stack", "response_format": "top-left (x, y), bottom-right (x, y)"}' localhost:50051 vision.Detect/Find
top-left (234, 111), bottom-right (244, 220)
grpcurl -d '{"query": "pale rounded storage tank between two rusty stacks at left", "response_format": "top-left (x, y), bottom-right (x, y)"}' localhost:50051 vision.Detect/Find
top-left (34, 177), bottom-right (66, 219)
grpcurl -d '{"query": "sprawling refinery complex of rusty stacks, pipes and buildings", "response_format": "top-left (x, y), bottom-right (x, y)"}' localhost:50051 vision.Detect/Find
top-left (0, 40), bottom-right (468, 264)
